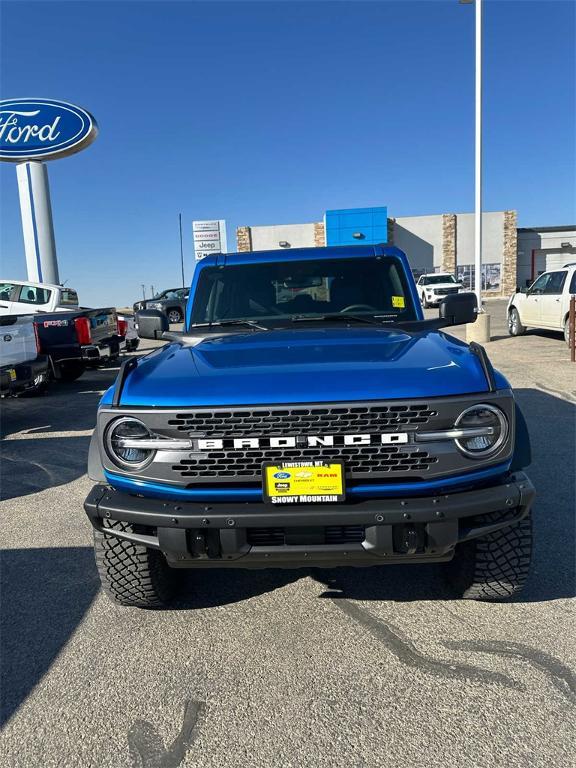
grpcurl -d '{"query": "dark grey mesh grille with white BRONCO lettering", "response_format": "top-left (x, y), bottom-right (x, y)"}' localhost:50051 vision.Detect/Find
top-left (99, 396), bottom-right (514, 489)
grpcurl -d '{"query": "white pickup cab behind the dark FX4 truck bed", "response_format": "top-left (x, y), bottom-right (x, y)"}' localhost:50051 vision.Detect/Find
top-left (0, 280), bottom-right (78, 316)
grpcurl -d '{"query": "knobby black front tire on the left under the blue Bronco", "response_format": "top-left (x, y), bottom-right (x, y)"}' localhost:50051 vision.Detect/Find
top-left (94, 521), bottom-right (175, 608)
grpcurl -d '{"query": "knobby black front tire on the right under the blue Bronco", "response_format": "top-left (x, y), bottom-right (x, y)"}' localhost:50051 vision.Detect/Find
top-left (445, 512), bottom-right (532, 601)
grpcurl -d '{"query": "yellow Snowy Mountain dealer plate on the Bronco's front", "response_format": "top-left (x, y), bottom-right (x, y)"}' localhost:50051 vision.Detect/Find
top-left (262, 461), bottom-right (345, 504)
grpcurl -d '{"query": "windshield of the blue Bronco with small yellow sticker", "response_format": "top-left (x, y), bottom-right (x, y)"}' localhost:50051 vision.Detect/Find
top-left (191, 257), bottom-right (417, 326)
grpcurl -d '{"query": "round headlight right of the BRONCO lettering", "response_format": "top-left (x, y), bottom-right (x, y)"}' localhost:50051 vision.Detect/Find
top-left (455, 403), bottom-right (508, 459)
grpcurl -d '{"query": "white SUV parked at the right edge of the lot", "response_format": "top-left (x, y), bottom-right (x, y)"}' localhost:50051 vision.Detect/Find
top-left (508, 263), bottom-right (576, 344)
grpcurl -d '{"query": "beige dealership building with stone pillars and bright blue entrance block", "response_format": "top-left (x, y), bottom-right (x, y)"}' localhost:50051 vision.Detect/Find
top-left (236, 206), bottom-right (576, 296)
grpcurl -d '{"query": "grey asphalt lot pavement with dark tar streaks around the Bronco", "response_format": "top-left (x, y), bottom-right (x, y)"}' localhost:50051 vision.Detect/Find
top-left (0, 302), bottom-right (576, 768)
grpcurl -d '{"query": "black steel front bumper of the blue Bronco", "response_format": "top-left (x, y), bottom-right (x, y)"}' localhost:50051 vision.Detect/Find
top-left (84, 472), bottom-right (535, 568)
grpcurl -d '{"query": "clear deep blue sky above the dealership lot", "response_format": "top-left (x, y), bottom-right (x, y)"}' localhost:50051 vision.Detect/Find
top-left (0, 0), bottom-right (576, 305)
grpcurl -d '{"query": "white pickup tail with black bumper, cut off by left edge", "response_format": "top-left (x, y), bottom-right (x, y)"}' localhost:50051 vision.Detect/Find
top-left (0, 315), bottom-right (49, 397)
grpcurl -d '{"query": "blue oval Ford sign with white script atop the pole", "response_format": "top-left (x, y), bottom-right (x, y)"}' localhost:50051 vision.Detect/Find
top-left (0, 99), bottom-right (98, 163)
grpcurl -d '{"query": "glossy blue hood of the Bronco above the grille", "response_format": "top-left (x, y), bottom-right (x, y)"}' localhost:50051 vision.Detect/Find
top-left (113, 327), bottom-right (496, 407)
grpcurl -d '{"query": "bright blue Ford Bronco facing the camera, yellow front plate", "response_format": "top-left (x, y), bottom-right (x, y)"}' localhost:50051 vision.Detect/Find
top-left (85, 246), bottom-right (534, 608)
